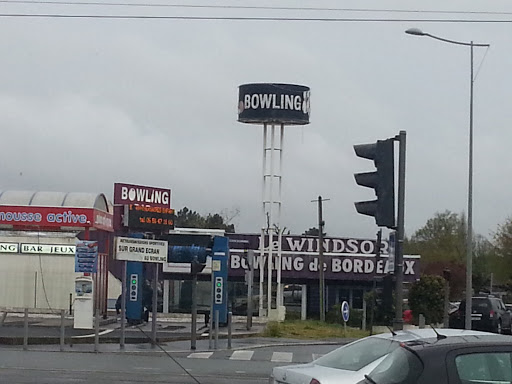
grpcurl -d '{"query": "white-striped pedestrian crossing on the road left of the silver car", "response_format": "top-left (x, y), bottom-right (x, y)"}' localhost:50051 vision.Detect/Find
top-left (187, 349), bottom-right (323, 364)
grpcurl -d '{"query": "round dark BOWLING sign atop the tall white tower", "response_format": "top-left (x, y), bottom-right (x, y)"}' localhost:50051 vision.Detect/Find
top-left (238, 83), bottom-right (311, 125)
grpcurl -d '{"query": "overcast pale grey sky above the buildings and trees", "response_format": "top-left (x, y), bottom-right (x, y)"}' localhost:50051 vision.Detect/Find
top-left (0, 0), bottom-right (512, 237)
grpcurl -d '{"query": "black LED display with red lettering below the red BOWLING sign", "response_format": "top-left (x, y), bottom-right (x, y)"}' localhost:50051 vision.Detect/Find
top-left (123, 204), bottom-right (174, 232)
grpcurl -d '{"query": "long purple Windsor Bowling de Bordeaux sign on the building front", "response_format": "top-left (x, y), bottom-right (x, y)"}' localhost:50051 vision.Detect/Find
top-left (228, 234), bottom-right (420, 281)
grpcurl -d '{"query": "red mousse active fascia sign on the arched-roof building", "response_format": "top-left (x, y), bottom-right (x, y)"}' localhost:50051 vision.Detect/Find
top-left (0, 205), bottom-right (113, 232)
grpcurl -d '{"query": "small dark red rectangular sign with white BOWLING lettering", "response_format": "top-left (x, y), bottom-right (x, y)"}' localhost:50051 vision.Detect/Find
top-left (114, 183), bottom-right (171, 208)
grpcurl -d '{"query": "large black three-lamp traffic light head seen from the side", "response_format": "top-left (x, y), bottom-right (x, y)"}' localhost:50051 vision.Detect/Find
top-left (354, 139), bottom-right (395, 228)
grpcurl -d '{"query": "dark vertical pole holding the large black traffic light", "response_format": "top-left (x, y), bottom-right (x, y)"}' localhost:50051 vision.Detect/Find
top-left (393, 131), bottom-right (406, 331)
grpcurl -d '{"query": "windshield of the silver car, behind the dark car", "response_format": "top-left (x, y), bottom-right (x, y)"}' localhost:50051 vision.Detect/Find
top-left (315, 337), bottom-right (399, 371)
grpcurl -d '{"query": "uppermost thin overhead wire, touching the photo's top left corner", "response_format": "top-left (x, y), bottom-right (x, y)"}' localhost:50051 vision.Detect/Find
top-left (0, 0), bottom-right (512, 15)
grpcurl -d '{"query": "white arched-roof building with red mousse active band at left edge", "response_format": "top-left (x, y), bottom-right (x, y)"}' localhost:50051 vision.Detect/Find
top-left (0, 191), bottom-right (113, 328)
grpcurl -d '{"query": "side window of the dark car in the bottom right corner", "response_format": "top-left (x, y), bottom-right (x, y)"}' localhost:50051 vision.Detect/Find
top-left (455, 352), bottom-right (512, 384)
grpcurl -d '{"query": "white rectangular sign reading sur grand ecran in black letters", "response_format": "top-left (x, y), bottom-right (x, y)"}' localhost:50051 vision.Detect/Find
top-left (115, 237), bottom-right (168, 263)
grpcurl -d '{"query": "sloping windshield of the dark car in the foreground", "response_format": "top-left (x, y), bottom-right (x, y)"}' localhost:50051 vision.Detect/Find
top-left (368, 348), bottom-right (423, 384)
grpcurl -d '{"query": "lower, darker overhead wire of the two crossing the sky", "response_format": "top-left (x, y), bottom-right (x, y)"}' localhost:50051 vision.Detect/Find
top-left (0, 13), bottom-right (512, 24)
